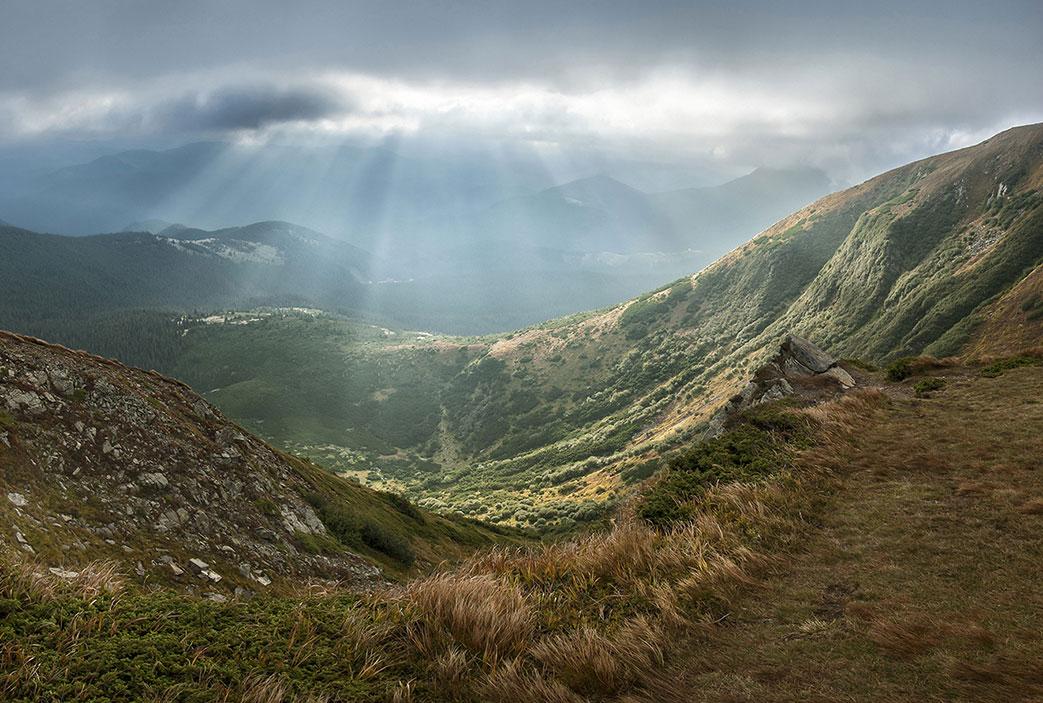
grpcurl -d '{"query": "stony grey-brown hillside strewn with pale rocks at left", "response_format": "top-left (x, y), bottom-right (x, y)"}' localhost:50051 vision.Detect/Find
top-left (0, 333), bottom-right (382, 593)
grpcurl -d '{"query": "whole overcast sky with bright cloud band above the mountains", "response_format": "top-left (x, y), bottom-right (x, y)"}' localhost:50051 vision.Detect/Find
top-left (0, 0), bottom-right (1043, 181)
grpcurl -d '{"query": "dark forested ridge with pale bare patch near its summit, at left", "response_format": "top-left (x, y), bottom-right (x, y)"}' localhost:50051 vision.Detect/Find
top-left (0, 222), bottom-right (372, 331)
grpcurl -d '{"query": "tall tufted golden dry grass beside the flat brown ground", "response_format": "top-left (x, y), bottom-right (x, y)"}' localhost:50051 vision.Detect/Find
top-left (379, 427), bottom-right (826, 703)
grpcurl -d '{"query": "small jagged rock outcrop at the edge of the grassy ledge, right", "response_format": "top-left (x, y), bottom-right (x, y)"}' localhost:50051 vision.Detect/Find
top-left (706, 335), bottom-right (857, 437)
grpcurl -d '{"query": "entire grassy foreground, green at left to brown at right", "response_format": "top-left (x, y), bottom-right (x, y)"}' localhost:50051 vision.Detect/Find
top-left (0, 352), bottom-right (1043, 703)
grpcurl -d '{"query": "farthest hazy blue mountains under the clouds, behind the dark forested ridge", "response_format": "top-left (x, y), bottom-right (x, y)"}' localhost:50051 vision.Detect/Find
top-left (0, 142), bottom-right (829, 256)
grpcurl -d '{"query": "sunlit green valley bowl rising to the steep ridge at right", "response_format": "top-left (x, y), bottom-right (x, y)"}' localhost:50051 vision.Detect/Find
top-left (156, 125), bottom-right (1043, 527)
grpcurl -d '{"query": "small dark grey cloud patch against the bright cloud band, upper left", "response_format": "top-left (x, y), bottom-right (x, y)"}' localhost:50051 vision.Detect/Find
top-left (151, 86), bottom-right (351, 132)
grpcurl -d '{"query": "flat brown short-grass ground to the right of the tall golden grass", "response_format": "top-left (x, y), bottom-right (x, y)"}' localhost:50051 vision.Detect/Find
top-left (635, 368), bottom-right (1043, 703)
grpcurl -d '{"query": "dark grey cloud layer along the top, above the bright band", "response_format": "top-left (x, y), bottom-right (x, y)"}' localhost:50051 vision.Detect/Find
top-left (0, 0), bottom-right (1043, 90)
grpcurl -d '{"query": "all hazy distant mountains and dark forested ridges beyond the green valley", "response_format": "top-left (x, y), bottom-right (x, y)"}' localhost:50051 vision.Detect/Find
top-left (0, 143), bottom-right (829, 337)
